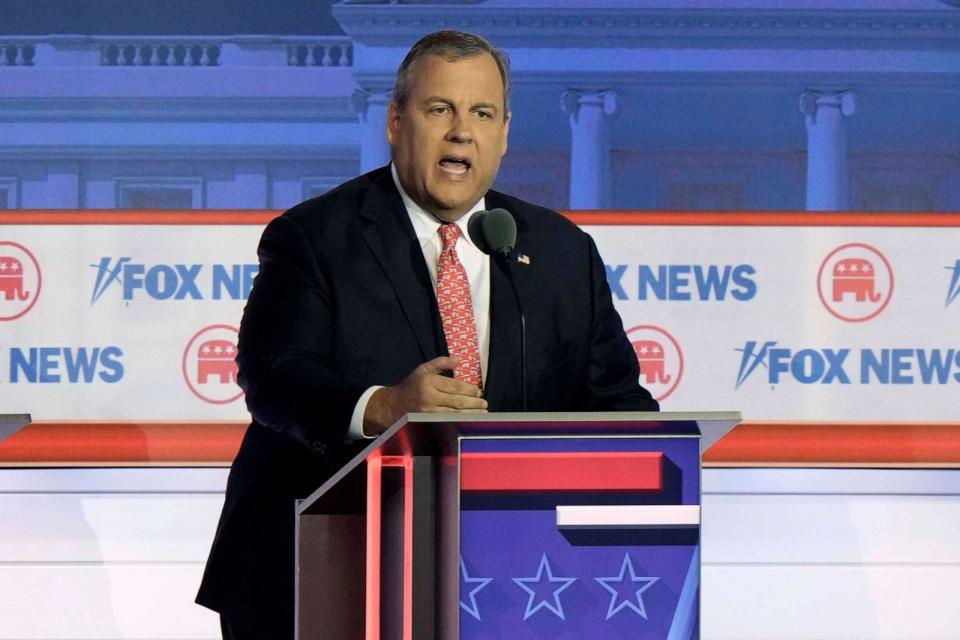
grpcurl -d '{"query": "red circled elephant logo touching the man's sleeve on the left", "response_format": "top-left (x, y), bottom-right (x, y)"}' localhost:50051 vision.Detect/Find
top-left (182, 324), bottom-right (243, 404)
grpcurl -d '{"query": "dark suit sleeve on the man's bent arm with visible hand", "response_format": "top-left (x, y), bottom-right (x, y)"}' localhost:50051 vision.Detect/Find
top-left (237, 216), bottom-right (366, 455)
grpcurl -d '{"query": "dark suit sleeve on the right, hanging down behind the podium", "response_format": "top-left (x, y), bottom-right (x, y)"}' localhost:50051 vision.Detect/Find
top-left (587, 236), bottom-right (660, 411)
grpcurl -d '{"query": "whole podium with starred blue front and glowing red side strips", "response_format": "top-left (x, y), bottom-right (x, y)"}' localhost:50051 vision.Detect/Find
top-left (296, 412), bottom-right (740, 640)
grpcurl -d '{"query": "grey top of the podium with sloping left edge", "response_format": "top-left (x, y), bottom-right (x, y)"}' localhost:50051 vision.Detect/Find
top-left (298, 411), bottom-right (741, 513)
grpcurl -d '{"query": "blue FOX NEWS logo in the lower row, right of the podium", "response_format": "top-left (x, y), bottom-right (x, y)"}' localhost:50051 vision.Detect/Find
top-left (735, 340), bottom-right (960, 389)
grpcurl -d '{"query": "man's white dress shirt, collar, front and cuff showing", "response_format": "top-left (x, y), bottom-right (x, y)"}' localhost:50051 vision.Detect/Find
top-left (347, 163), bottom-right (490, 440)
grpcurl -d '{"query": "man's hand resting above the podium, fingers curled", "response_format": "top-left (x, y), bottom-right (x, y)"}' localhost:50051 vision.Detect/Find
top-left (363, 358), bottom-right (487, 436)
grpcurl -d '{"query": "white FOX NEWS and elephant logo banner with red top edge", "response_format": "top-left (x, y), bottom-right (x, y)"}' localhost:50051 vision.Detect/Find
top-left (0, 211), bottom-right (960, 420)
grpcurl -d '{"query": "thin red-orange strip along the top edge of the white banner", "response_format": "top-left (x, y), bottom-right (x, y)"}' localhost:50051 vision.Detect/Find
top-left (0, 209), bottom-right (960, 227)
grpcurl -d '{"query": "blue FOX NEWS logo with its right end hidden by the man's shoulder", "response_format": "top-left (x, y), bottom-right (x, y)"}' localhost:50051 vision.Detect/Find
top-left (90, 256), bottom-right (259, 305)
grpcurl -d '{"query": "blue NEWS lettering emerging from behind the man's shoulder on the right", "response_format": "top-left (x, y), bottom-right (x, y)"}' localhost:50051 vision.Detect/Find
top-left (606, 264), bottom-right (757, 302)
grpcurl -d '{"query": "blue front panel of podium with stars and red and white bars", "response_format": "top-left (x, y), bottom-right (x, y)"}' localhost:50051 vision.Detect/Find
top-left (460, 436), bottom-right (700, 640)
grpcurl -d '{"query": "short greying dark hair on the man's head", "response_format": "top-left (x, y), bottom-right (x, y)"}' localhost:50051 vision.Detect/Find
top-left (393, 31), bottom-right (510, 119)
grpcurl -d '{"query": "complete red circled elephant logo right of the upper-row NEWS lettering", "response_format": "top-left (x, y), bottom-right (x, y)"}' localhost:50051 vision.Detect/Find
top-left (817, 242), bottom-right (893, 322)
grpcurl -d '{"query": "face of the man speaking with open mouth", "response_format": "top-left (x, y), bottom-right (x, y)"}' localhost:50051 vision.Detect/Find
top-left (387, 53), bottom-right (510, 222)
